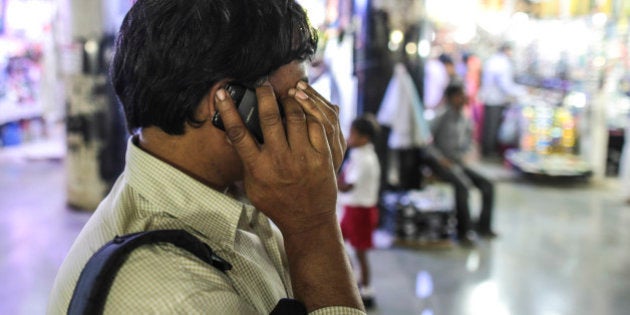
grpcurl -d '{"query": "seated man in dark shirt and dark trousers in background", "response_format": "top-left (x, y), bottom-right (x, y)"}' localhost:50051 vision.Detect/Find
top-left (423, 83), bottom-right (496, 246)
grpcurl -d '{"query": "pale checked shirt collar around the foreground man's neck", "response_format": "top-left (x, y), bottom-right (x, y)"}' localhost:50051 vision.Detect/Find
top-left (125, 137), bottom-right (253, 248)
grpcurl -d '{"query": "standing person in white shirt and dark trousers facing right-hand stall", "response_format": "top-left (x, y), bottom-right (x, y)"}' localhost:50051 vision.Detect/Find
top-left (479, 44), bottom-right (523, 157)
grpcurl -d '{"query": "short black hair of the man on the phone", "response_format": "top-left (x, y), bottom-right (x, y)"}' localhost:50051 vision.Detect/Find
top-left (111, 0), bottom-right (317, 135)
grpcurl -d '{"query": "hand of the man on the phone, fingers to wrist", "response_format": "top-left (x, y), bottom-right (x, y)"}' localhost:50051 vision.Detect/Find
top-left (217, 81), bottom-right (342, 236)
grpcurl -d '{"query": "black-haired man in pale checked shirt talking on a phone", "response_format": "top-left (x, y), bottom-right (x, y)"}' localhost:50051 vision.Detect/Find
top-left (48, 0), bottom-right (364, 314)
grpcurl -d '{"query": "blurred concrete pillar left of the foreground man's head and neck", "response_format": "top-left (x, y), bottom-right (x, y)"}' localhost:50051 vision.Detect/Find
top-left (60, 0), bottom-right (130, 211)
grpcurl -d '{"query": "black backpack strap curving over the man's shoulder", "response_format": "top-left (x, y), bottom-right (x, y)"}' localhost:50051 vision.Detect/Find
top-left (68, 230), bottom-right (232, 315)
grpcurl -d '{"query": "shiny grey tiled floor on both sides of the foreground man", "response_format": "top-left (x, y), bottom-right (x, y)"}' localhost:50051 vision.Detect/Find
top-left (0, 141), bottom-right (630, 315)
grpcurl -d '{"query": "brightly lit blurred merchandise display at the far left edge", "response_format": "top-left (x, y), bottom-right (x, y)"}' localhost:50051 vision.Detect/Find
top-left (0, 0), bottom-right (55, 147)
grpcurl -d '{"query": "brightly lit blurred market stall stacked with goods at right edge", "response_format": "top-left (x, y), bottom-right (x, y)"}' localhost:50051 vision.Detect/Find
top-left (505, 12), bottom-right (630, 183)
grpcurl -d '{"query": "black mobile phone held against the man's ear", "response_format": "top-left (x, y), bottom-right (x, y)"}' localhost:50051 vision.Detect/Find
top-left (212, 83), bottom-right (263, 143)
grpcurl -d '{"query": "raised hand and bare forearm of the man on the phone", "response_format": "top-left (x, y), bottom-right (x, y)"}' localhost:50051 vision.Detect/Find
top-left (216, 83), bottom-right (363, 312)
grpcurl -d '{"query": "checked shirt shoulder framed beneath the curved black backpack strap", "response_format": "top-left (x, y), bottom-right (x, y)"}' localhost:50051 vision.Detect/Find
top-left (106, 243), bottom-right (233, 314)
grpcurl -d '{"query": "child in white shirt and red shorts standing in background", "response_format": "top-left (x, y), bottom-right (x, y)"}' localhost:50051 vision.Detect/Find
top-left (337, 114), bottom-right (381, 308)
